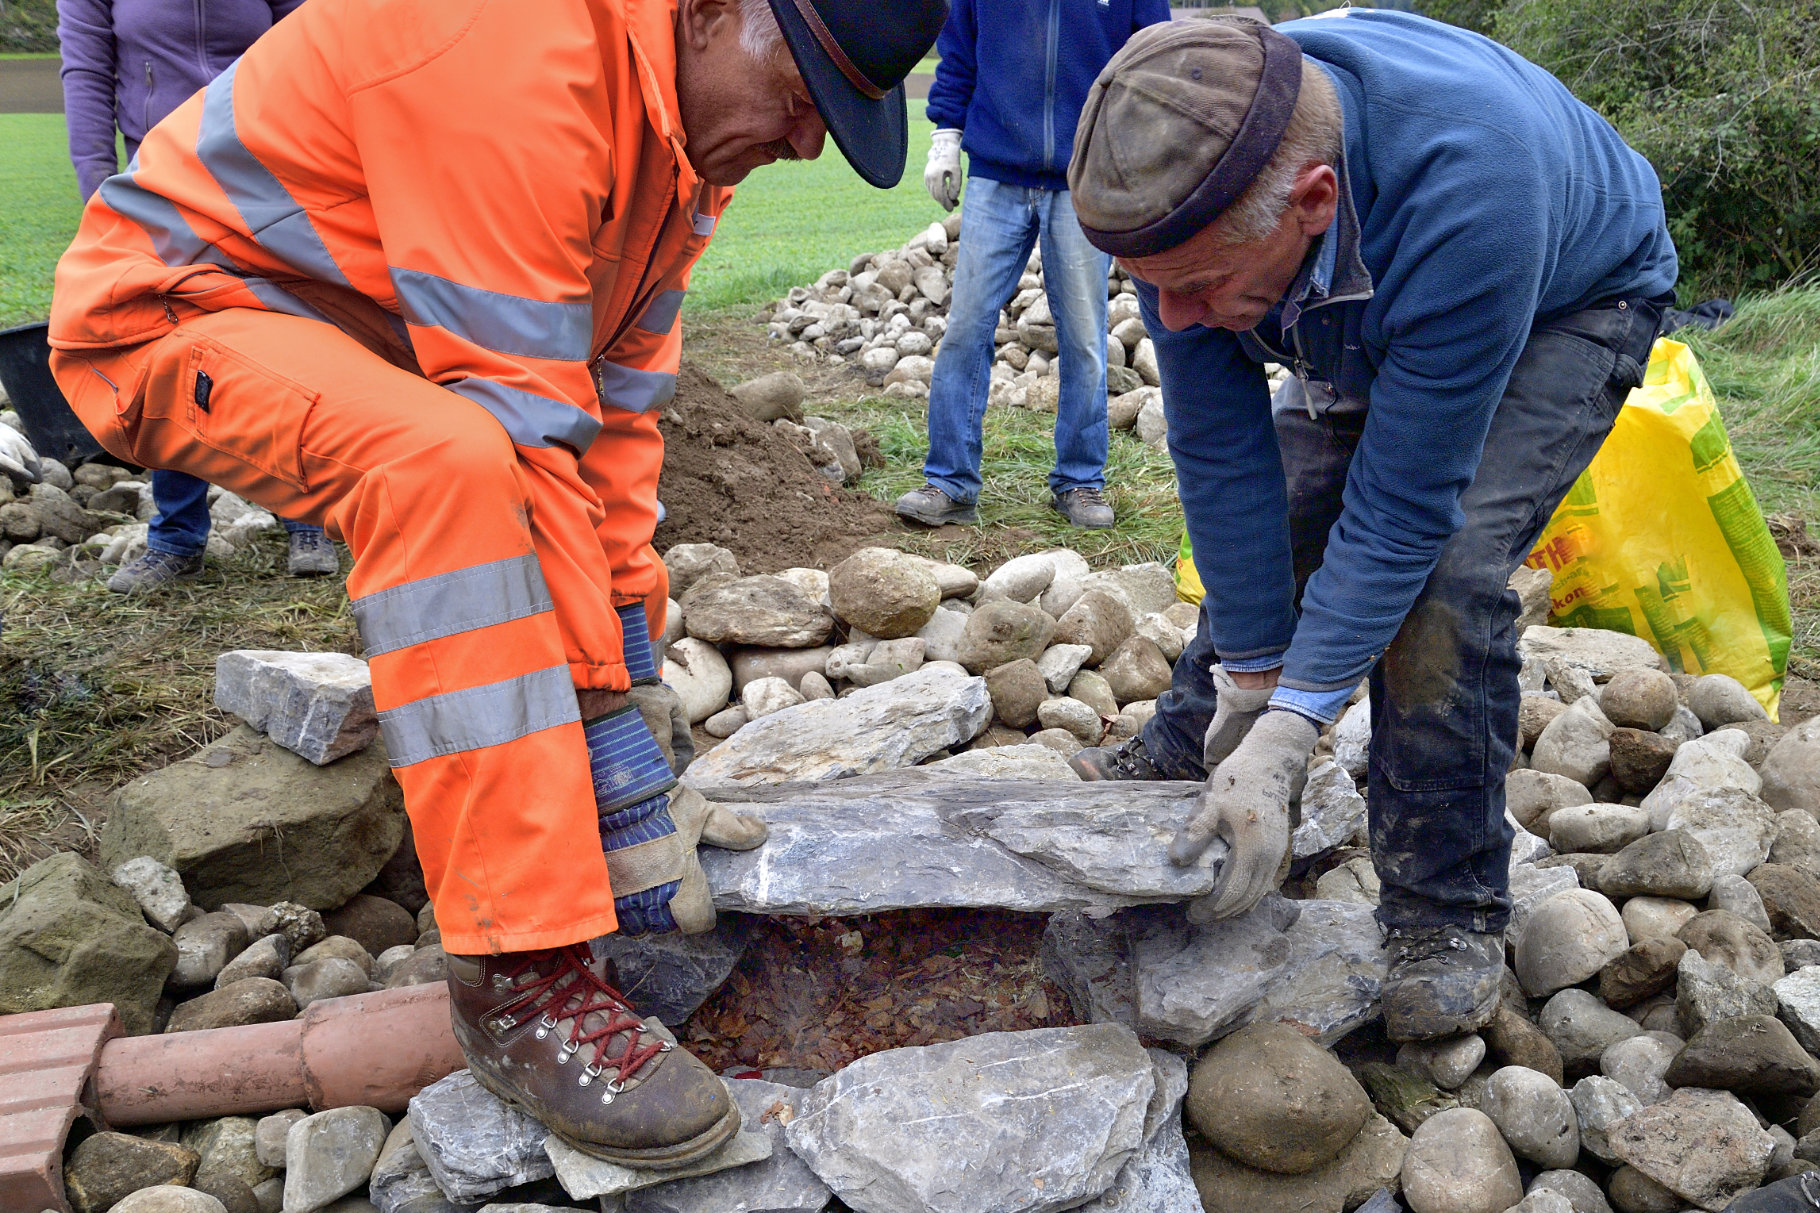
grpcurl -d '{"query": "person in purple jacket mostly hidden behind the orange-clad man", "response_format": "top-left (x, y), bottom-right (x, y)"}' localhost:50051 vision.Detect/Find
top-left (56, 0), bottom-right (340, 594)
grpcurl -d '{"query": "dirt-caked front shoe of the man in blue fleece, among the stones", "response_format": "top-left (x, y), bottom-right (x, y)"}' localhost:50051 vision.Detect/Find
top-left (1381, 925), bottom-right (1503, 1042)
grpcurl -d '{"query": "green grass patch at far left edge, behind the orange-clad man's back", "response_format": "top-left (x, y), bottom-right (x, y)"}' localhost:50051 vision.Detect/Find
top-left (0, 113), bottom-right (82, 328)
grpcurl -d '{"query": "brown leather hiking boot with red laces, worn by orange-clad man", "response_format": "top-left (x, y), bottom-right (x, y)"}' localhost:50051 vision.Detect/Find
top-left (450, 943), bottom-right (739, 1169)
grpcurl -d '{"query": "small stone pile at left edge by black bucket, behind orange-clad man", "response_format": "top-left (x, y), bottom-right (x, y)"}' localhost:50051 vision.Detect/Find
top-left (0, 410), bottom-right (278, 572)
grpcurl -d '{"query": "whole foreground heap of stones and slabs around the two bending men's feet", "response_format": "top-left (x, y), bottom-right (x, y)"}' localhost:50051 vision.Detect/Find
top-left (17, 545), bottom-right (1820, 1213)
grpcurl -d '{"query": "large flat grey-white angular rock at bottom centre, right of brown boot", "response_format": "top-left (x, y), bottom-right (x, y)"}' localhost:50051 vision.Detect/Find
top-left (784, 1024), bottom-right (1156, 1213)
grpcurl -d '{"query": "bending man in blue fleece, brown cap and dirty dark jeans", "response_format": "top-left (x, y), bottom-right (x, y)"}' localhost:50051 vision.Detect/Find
top-left (1068, 9), bottom-right (1676, 1040)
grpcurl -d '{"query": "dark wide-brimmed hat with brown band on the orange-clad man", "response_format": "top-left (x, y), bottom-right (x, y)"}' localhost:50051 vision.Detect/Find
top-left (770, 0), bottom-right (948, 189)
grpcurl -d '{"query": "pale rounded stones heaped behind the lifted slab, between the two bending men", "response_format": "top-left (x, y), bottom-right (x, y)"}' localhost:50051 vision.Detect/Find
top-left (664, 545), bottom-right (1196, 785)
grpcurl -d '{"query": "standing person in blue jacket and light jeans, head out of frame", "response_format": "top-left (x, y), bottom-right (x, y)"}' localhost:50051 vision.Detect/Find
top-left (897, 0), bottom-right (1168, 526)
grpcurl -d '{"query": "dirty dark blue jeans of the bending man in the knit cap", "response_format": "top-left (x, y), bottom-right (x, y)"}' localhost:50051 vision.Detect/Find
top-left (1143, 299), bottom-right (1665, 931)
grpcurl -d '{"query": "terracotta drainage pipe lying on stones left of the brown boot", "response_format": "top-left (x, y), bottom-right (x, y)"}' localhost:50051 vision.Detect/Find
top-left (95, 982), bottom-right (468, 1126)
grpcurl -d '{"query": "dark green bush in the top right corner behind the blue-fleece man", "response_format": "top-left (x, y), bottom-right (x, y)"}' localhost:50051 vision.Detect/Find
top-left (1485, 0), bottom-right (1820, 299)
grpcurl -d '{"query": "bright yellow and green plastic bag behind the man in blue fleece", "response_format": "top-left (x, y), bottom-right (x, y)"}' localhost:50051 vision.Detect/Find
top-left (1176, 337), bottom-right (1793, 719)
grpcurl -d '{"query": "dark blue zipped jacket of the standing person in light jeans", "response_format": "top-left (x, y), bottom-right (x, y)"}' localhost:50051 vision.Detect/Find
top-left (926, 0), bottom-right (1168, 189)
